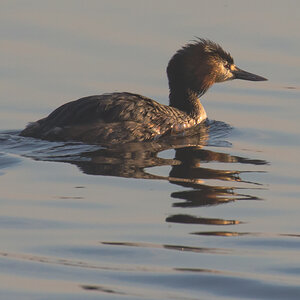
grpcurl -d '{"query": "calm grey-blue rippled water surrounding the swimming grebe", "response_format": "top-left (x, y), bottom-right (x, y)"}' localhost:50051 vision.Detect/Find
top-left (0, 0), bottom-right (300, 300)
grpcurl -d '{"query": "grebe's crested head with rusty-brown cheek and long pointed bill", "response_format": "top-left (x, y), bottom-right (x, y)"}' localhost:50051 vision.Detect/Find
top-left (167, 39), bottom-right (267, 95)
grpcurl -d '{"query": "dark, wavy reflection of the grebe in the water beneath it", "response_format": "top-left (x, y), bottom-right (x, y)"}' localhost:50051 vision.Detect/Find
top-left (19, 122), bottom-right (268, 229)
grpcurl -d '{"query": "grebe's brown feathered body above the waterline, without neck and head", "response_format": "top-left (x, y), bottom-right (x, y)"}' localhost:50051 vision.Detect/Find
top-left (21, 93), bottom-right (188, 143)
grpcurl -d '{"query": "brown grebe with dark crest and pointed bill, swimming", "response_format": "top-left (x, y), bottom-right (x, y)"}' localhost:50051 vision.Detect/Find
top-left (20, 39), bottom-right (267, 144)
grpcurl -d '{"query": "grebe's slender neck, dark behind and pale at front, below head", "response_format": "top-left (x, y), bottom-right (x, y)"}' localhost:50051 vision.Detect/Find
top-left (169, 88), bottom-right (206, 118)
